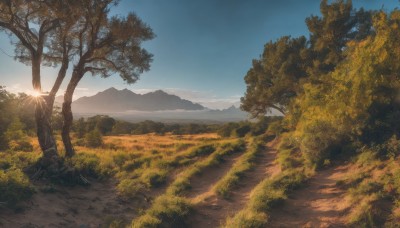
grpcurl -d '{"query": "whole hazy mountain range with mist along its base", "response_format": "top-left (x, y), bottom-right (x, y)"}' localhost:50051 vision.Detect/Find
top-left (55, 88), bottom-right (248, 123)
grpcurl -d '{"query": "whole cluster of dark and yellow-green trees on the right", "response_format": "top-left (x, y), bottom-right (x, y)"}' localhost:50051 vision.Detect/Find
top-left (241, 0), bottom-right (400, 165)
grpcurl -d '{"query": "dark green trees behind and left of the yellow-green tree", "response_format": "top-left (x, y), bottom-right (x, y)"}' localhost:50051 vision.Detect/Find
top-left (241, 0), bottom-right (374, 117)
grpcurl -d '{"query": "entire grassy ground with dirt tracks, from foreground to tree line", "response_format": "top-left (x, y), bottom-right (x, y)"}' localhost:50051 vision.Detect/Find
top-left (0, 134), bottom-right (400, 227)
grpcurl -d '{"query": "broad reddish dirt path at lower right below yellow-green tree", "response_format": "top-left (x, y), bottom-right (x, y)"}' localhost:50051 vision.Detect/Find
top-left (268, 165), bottom-right (350, 227)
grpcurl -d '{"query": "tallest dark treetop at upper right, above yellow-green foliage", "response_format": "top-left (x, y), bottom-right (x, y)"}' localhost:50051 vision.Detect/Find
top-left (306, 0), bottom-right (372, 75)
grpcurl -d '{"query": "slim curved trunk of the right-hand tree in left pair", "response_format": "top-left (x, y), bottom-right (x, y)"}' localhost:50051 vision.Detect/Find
top-left (61, 73), bottom-right (82, 157)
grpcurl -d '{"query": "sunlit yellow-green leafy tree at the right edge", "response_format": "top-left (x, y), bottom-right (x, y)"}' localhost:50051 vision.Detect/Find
top-left (286, 10), bottom-right (400, 165)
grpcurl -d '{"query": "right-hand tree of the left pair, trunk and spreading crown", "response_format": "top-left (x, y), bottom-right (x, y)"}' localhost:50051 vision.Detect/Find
top-left (62, 0), bottom-right (154, 157)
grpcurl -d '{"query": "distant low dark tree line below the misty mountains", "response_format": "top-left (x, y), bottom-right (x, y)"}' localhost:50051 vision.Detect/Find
top-left (0, 86), bottom-right (281, 151)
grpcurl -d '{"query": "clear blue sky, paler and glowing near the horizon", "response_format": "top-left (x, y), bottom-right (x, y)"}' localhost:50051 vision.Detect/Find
top-left (0, 0), bottom-right (400, 108)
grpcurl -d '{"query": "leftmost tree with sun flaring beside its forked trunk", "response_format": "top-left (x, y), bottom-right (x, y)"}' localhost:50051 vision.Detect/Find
top-left (0, 0), bottom-right (74, 170)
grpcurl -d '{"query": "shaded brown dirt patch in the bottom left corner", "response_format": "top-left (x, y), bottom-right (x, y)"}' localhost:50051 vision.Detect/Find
top-left (0, 181), bottom-right (138, 228)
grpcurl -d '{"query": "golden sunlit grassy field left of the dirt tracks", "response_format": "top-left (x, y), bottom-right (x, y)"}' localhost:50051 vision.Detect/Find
top-left (0, 134), bottom-right (258, 227)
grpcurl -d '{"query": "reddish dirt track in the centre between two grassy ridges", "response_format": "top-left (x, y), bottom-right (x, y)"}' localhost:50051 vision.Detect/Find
top-left (190, 142), bottom-right (280, 228)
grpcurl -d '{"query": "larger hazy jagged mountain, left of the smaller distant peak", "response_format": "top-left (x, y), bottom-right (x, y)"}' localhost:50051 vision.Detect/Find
top-left (72, 87), bottom-right (205, 113)
